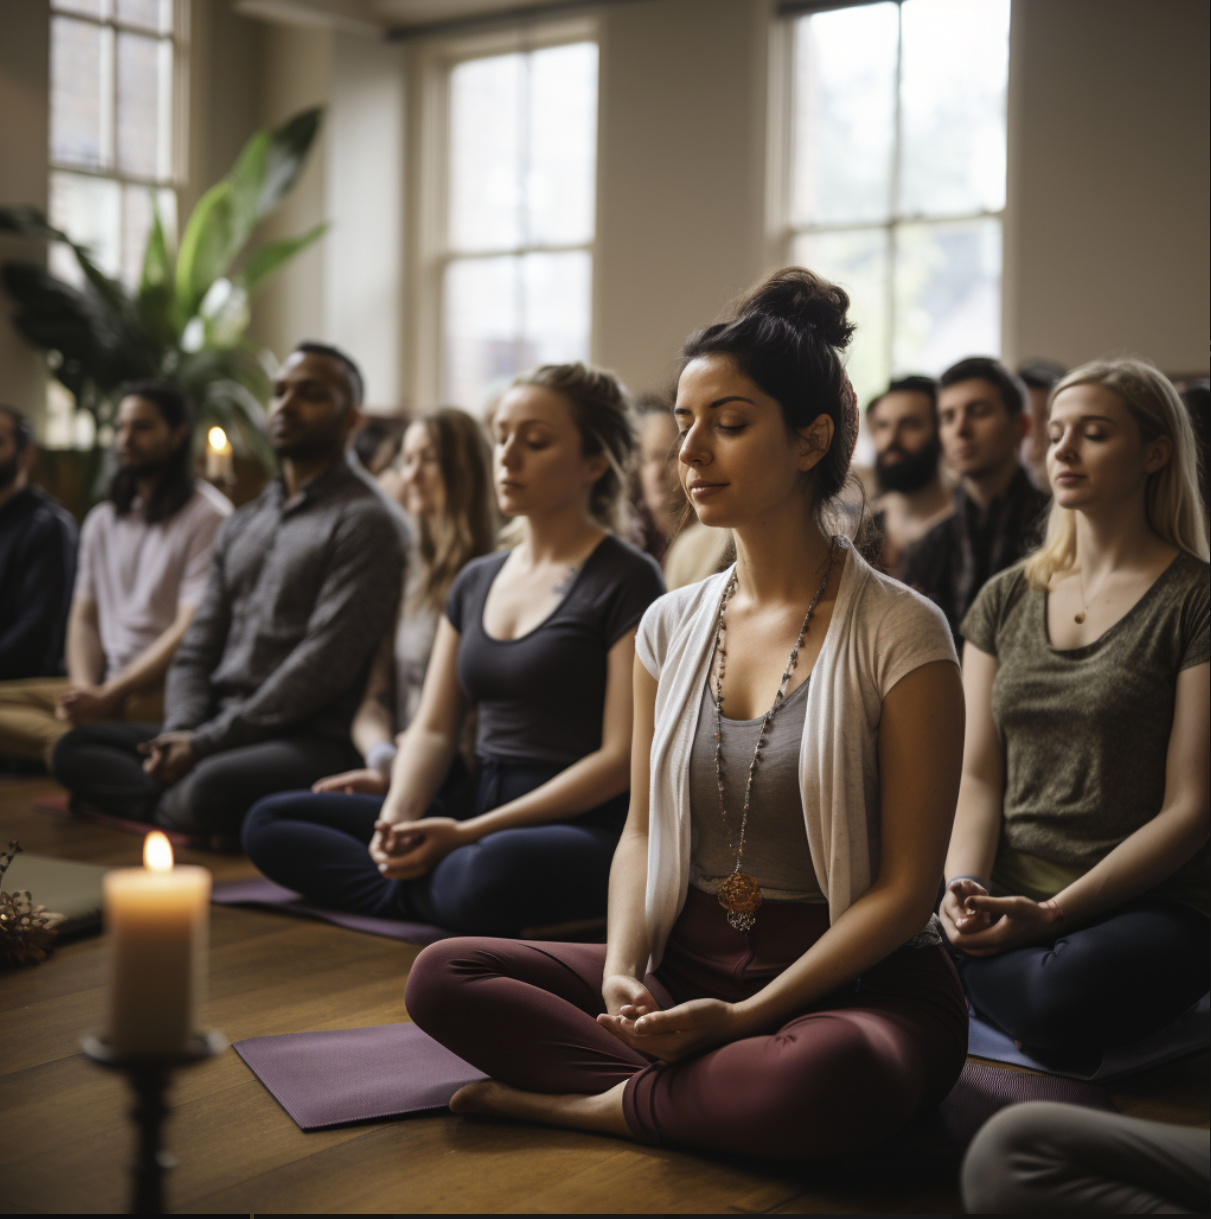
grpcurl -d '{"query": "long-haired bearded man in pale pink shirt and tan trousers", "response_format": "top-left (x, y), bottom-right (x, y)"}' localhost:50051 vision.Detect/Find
top-left (0, 380), bottom-right (232, 764)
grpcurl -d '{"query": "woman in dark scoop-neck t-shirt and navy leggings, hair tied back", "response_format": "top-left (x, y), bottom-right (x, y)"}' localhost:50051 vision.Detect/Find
top-left (244, 364), bottom-right (663, 935)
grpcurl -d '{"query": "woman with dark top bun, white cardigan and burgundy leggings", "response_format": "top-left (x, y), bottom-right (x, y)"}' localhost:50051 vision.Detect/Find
top-left (406, 268), bottom-right (967, 1158)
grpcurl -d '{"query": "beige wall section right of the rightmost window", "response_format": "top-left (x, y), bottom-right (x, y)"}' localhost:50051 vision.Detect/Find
top-left (1004, 0), bottom-right (1211, 373)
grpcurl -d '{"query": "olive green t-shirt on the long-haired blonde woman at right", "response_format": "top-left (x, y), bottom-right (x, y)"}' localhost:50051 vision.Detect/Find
top-left (960, 551), bottom-right (1211, 914)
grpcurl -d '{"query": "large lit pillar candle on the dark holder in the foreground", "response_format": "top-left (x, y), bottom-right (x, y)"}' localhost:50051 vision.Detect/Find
top-left (104, 830), bottom-right (210, 1058)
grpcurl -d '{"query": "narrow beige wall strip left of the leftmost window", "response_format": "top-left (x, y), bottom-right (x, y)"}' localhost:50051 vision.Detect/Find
top-left (0, 0), bottom-right (50, 432)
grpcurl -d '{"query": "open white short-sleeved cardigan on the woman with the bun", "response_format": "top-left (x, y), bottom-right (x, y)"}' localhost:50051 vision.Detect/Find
top-left (635, 544), bottom-right (959, 968)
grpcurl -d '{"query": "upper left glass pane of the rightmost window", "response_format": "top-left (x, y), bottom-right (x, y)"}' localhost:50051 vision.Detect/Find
top-left (793, 4), bottom-right (899, 223)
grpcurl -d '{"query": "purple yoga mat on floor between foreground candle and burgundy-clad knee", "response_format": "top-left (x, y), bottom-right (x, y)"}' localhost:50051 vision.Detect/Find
top-left (233, 1024), bottom-right (487, 1130)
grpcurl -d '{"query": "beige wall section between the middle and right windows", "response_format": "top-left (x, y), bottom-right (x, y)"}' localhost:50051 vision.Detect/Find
top-left (594, 0), bottom-right (768, 391)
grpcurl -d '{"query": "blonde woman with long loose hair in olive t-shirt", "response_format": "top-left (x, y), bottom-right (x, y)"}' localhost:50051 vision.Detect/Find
top-left (940, 360), bottom-right (1211, 1062)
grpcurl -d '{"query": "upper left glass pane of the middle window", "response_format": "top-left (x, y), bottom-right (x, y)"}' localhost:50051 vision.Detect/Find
top-left (450, 55), bottom-right (524, 250)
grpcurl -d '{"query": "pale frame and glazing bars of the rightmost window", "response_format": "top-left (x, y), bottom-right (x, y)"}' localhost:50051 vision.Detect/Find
top-left (770, 0), bottom-right (1012, 394)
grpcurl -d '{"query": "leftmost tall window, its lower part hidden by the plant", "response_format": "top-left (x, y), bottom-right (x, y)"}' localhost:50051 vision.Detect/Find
top-left (50, 0), bottom-right (177, 292)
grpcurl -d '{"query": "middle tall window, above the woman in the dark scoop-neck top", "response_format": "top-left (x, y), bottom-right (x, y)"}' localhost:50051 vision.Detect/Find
top-left (441, 43), bottom-right (598, 410)
